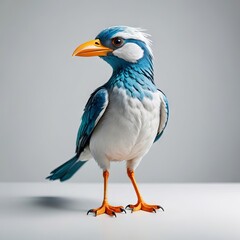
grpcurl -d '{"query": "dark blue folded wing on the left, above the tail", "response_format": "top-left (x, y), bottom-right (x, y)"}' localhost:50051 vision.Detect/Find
top-left (76, 87), bottom-right (108, 157)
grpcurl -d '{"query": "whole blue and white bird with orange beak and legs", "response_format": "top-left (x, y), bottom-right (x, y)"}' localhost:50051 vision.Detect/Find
top-left (47, 26), bottom-right (169, 216)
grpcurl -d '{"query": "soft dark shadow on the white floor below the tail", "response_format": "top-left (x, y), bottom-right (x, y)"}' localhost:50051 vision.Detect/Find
top-left (22, 196), bottom-right (100, 215)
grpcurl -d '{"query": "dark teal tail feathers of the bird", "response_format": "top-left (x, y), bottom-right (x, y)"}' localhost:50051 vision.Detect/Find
top-left (46, 155), bottom-right (86, 182)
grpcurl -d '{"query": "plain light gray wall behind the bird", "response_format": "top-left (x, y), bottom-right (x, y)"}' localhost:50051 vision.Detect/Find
top-left (0, 0), bottom-right (240, 182)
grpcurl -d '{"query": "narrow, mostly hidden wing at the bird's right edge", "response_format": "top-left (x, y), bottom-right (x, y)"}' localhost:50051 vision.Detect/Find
top-left (154, 89), bottom-right (169, 142)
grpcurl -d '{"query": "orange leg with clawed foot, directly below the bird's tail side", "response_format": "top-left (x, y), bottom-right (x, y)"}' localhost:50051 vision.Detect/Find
top-left (87, 170), bottom-right (126, 217)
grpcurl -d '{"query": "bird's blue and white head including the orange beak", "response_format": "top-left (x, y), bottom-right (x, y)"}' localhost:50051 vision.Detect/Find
top-left (73, 26), bottom-right (152, 70)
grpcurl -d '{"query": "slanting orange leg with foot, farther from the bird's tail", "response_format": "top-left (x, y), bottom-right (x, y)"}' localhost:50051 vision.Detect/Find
top-left (126, 168), bottom-right (164, 212)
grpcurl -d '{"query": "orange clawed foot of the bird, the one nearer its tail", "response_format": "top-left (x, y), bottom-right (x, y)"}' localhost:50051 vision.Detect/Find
top-left (87, 202), bottom-right (126, 217)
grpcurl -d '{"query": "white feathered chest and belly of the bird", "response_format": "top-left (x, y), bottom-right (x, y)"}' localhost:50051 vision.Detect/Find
top-left (90, 88), bottom-right (160, 160)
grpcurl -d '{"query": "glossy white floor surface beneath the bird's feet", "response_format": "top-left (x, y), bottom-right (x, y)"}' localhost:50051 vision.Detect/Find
top-left (0, 182), bottom-right (240, 240)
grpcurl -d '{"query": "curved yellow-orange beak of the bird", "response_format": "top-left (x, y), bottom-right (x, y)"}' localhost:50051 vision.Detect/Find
top-left (72, 39), bottom-right (113, 57)
